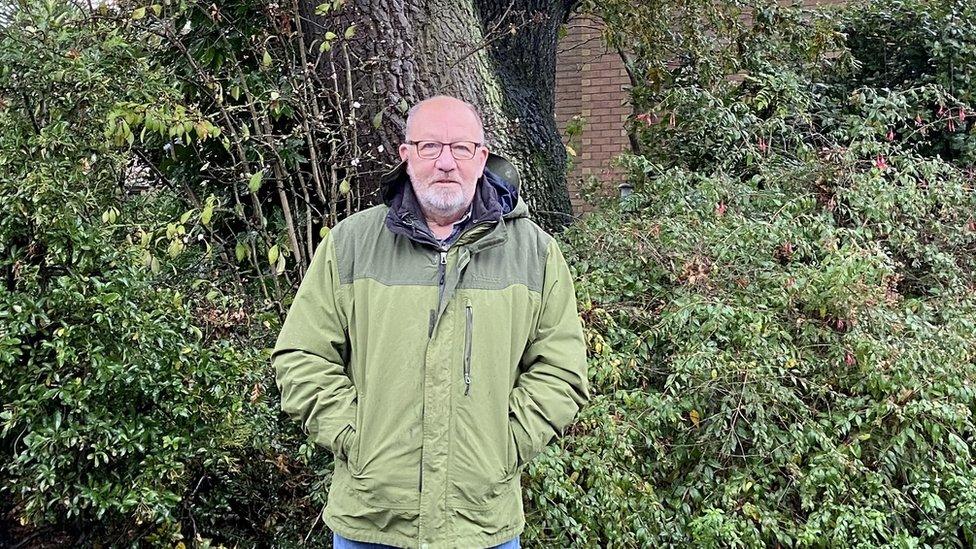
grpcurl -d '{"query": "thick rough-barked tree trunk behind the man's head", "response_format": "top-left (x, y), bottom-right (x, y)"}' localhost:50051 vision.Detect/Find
top-left (303, 0), bottom-right (575, 229)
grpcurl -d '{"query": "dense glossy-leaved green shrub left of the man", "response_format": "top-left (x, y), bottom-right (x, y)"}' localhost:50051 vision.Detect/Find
top-left (0, 2), bottom-right (323, 546)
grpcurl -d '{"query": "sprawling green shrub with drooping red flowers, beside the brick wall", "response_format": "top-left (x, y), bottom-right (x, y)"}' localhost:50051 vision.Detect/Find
top-left (526, 2), bottom-right (976, 547)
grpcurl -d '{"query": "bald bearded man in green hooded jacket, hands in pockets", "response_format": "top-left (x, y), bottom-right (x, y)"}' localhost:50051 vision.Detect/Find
top-left (272, 96), bottom-right (589, 549)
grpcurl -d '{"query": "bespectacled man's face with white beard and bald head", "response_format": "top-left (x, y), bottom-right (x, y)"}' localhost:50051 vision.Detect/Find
top-left (399, 98), bottom-right (488, 220)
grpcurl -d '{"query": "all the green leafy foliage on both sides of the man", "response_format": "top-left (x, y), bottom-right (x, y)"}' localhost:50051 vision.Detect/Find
top-left (0, 0), bottom-right (976, 547)
